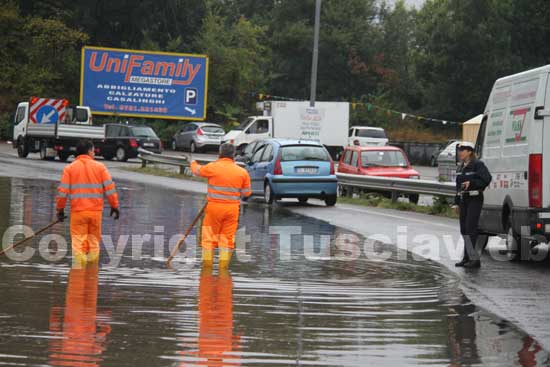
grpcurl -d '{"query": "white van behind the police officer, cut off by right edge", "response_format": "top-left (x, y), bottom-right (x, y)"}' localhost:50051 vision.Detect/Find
top-left (476, 65), bottom-right (550, 260)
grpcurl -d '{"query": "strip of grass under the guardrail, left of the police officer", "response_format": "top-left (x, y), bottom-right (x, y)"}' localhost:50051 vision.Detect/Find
top-left (338, 194), bottom-right (458, 218)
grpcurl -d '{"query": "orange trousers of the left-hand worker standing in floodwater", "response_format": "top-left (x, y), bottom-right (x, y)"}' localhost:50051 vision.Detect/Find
top-left (71, 211), bottom-right (103, 260)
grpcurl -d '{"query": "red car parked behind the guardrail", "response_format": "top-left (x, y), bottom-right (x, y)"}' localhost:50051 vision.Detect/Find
top-left (338, 146), bottom-right (420, 204)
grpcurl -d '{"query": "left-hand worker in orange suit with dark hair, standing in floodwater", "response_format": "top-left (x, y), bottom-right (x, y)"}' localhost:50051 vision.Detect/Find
top-left (56, 140), bottom-right (120, 265)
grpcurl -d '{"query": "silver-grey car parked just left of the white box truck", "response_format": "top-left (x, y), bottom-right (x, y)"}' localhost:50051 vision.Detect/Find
top-left (172, 122), bottom-right (225, 153)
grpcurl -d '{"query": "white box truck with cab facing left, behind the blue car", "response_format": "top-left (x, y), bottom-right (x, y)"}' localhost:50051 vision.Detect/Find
top-left (223, 101), bottom-right (349, 156)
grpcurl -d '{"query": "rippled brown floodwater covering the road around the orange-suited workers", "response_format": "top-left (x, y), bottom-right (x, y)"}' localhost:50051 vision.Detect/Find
top-left (0, 178), bottom-right (549, 367)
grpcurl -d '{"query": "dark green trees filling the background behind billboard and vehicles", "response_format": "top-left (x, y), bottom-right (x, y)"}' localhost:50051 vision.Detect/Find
top-left (0, 0), bottom-right (550, 140)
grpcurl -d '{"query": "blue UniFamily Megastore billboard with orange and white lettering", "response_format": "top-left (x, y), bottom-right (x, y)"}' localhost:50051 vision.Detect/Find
top-left (80, 47), bottom-right (208, 120)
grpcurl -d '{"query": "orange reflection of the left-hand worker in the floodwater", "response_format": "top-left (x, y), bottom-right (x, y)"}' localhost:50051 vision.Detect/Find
top-left (49, 264), bottom-right (111, 367)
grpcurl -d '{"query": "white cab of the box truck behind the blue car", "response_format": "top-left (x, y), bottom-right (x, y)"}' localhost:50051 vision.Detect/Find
top-left (223, 116), bottom-right (273, 152)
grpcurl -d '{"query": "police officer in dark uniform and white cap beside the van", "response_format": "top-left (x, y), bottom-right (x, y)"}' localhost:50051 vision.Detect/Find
top-left (455, 142), bottom-right (492, 268)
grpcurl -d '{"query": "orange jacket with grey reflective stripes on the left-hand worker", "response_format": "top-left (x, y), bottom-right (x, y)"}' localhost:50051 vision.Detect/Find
top-left (56, 155), bottom-right (118, 212)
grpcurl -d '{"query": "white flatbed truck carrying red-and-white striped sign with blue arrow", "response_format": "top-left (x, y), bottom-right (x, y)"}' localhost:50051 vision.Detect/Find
top-left (13, 97), bottom-right (105, 161)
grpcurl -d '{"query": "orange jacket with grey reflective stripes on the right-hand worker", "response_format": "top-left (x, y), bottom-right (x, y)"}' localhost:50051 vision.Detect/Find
top-left (191, 158), bottom-right (252, 205)
